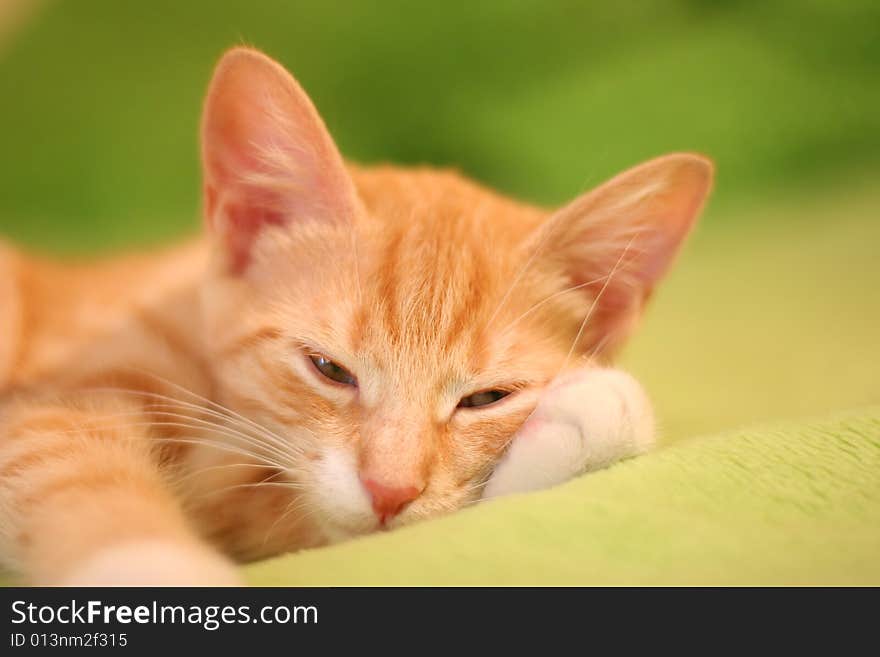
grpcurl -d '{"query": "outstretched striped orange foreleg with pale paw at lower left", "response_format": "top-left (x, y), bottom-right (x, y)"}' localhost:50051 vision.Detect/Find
top-left (0, 395), bottom-right (240, 586)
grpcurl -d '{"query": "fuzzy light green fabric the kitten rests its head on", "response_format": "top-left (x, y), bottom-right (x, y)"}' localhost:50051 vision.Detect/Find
top-left (247, 407), bottom-right (880, 586)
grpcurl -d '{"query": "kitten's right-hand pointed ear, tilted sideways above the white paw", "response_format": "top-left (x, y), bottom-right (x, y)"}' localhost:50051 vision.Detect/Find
top-left (532, 153), bottom-right (713, 355)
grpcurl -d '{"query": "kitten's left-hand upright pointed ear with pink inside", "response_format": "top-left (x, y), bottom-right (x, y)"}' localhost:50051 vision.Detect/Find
top-left (202, 48), bottom-right (359, 272)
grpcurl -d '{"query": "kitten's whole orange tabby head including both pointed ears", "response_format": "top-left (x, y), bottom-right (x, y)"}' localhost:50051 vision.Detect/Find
top-left (202, 49), bottom-right (712, 539)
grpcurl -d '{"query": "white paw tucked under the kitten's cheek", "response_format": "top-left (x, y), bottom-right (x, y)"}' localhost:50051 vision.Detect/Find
top-left (483, 367), bottom-right (654, 498)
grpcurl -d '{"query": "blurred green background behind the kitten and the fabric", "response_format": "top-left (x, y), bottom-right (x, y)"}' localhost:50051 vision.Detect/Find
top-left (0, 0), bottom-right (880, 439)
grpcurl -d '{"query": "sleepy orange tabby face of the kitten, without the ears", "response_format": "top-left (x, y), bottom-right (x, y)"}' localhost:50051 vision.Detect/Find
top-left (202, 170), bottom-right (585, 538)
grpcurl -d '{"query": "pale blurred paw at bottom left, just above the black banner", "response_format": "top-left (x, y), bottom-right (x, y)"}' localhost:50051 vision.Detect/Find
top-left (52, 540), bottom-right (243, 586)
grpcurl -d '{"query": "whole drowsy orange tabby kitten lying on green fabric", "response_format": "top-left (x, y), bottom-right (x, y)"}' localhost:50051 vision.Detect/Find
top-left (0, 48), bottom-right (711, 584)
